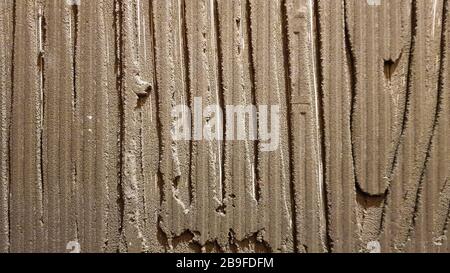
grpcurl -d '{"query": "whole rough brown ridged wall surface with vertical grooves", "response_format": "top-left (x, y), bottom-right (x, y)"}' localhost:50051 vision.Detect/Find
top-left (0, 0), bottom-right (450, 253)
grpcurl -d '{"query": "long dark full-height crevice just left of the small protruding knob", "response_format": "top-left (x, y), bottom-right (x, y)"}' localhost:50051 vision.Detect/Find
top-left (114, 0), bottom-right (128, 252)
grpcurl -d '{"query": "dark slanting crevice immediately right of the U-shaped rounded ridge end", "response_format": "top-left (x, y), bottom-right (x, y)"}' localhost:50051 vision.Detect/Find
top-left (379, 0), bottom-right (418, 236)
